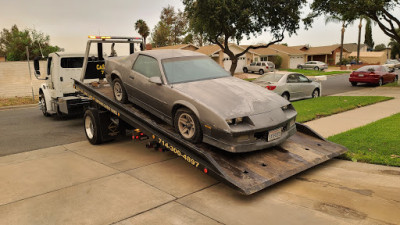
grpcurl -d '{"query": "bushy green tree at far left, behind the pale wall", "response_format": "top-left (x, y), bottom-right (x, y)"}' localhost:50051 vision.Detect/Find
top-left (0, 25), bottom-right (61, 61)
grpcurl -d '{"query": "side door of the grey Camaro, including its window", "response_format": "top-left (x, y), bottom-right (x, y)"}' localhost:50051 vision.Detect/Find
top-left (130, 55), bottom-right (169, 119)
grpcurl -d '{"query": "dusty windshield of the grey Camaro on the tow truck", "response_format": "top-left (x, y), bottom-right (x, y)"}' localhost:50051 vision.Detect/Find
top-left (162, 56), bottom-right (230, 84)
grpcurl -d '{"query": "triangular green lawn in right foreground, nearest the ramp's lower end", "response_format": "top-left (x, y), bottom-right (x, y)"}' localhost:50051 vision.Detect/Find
top-left (328, 113), bottom-right (400, 166)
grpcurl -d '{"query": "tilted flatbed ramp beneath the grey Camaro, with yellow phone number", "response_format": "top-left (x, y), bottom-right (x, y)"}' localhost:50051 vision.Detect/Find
top-left (74, 80), bottom-right (347, 195)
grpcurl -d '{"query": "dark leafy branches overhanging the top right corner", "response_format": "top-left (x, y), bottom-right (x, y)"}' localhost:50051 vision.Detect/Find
top-left (310, 0), bottom-right (400, 43)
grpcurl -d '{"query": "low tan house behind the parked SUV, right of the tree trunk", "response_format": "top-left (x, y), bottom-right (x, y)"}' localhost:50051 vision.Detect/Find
top-left (243, 45), bottom-right (306, 69)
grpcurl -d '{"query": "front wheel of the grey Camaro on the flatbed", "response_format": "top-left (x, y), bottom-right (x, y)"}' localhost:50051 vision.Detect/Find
top-left (174, 108), bottom-right (203, 144)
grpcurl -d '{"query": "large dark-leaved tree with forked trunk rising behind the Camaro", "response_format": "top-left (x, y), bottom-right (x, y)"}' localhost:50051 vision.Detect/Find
top-left (183, 0), bottom-right (306, 75)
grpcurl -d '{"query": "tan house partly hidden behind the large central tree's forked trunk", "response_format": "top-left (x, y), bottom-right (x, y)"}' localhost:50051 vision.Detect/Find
top-left (196, 43), bottom-right (259, 73)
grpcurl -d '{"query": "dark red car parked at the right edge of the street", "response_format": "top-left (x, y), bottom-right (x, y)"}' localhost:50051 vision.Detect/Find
top-left (349, 66), bottom-right (398, 86)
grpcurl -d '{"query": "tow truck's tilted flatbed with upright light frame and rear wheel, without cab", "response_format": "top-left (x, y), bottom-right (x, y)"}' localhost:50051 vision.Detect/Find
top-left (74, 36), bottom-right (347, 195)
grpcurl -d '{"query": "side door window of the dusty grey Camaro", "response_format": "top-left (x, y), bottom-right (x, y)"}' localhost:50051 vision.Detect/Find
top-left (132, 55), bottom-right (161, 78)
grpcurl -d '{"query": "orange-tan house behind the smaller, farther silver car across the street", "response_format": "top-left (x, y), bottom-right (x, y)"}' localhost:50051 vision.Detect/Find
top-left (292, 44), bottom-right (349, 66)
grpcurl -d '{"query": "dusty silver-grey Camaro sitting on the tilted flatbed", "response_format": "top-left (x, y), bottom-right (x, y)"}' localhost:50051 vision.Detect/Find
top-left (105, 50), bottom-right (297, 152)
